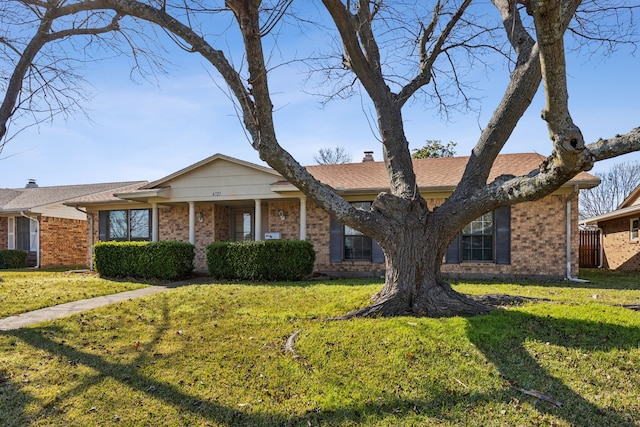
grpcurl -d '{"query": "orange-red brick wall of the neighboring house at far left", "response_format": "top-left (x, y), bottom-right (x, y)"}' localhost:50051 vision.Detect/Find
top-left (40, 216), bottom-right (88, 267)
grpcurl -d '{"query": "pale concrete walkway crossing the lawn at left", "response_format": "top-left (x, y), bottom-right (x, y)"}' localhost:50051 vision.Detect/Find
top-left (0, 279), bottom-right (207, 331)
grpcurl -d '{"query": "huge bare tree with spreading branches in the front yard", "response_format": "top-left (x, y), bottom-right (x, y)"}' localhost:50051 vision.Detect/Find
top-left (0, 0), bottom-right (640, 317)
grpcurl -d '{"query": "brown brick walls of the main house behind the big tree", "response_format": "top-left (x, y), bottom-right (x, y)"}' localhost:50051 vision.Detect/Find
top-left (85, 195), bottom-right (579, 278)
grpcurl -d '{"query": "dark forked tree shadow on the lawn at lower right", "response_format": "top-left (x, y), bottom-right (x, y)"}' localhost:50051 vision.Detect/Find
top-left (467, 310), bottom-right (640, 427)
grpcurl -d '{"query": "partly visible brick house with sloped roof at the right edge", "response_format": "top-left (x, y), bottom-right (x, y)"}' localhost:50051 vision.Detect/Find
top-left (580, 186), bottom-right (640, 271)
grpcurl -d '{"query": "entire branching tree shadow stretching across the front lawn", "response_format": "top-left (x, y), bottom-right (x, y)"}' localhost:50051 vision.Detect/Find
top-left (0, 304), bottom-right (640, 427)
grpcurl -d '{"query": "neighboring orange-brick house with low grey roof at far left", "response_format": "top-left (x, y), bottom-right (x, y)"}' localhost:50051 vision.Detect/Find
top-left (0, 180), bottom-right (145, 267)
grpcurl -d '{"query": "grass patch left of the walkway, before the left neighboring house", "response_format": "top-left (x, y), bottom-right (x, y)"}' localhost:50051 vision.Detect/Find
top-left (0, 270), bottom-right (147, 318)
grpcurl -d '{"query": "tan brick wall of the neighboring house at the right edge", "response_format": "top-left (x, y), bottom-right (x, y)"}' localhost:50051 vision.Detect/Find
top-left (600, 218), bottom-right (640, 271)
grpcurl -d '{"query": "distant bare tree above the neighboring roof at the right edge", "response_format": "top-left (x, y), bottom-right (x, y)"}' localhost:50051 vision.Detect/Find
top-left (580, 162), bottom-right (640, 219)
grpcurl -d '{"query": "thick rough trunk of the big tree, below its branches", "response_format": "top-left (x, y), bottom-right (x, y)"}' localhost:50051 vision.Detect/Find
top-left (344, 198), bottom-right (492, 318)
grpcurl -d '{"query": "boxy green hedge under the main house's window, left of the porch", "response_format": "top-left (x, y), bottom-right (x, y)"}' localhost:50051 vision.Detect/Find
top-left (93, 241), bottom-right (195, 280)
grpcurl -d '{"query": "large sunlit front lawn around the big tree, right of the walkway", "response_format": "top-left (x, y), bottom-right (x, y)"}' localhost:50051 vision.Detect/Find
top-left (0, 272), bottom-right (640, 426)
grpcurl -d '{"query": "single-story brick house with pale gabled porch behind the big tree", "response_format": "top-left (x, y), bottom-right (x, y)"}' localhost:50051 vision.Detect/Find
top-left (67, 154), bottom-right (599, 279)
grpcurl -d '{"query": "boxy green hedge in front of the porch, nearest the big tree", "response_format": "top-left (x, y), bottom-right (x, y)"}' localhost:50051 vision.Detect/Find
top-left (207, 240), bottom-right (316, 280)
